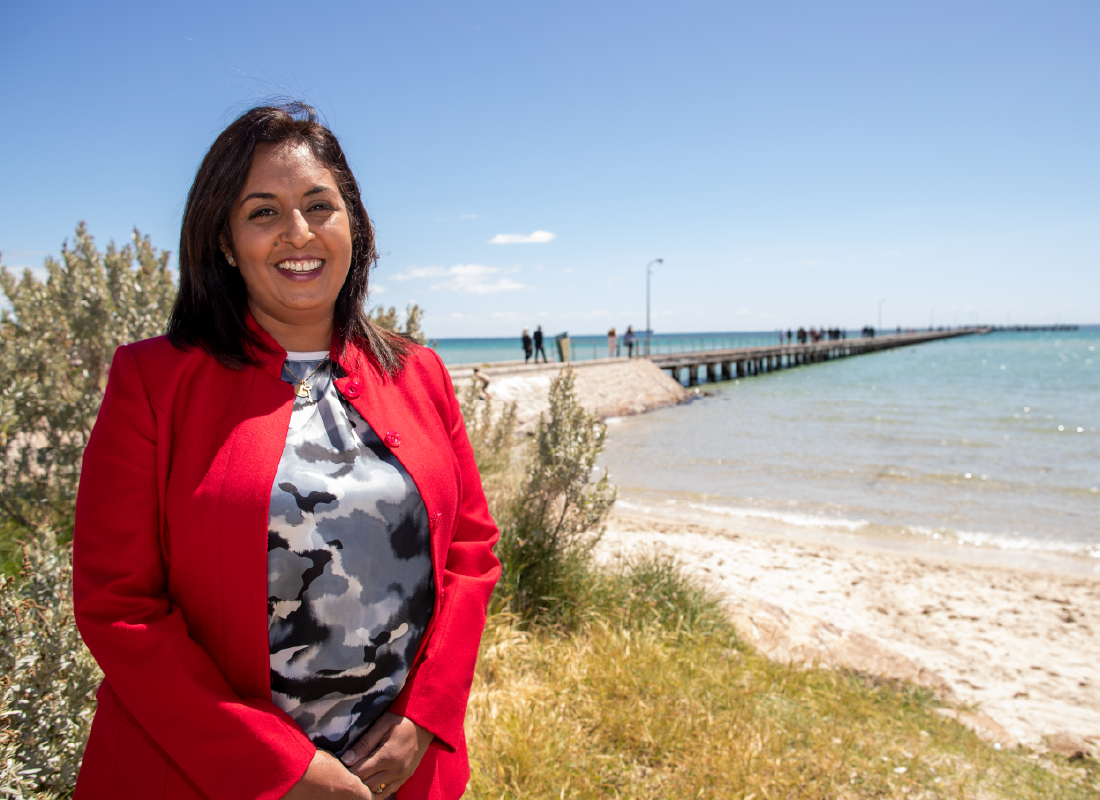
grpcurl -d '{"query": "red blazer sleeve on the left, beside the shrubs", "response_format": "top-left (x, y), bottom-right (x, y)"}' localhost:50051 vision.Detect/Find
top-left (73, 347), bottom-right (315, 800)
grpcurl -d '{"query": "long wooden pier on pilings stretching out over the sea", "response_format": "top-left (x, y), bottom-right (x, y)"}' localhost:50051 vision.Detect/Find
top-left (639, 328), bottom-right (989, 386)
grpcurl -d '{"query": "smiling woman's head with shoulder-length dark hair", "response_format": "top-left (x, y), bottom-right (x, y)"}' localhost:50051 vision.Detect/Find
top-left (168, 105), bottom-right (411, 374)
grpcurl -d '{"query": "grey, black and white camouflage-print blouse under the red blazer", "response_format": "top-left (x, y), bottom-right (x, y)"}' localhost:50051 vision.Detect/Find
top-left (267, 353), bottom-right (435, 755)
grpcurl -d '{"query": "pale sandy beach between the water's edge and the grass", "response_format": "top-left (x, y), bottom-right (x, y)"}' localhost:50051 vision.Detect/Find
top-left (600, 511), bottom-right (1100, 747)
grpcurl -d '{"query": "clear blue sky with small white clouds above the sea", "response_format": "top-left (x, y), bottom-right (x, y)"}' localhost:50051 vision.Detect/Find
top-left (0, 0), bottom-right (1100, 337)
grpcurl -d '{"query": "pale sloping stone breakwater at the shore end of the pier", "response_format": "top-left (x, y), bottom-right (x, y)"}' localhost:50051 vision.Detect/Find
top-left (448, 359), bottom-right (691, 432)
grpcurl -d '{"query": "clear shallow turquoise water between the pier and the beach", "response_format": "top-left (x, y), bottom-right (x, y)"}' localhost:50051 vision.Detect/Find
top-left (603, 328), bottom-right (1100, 573)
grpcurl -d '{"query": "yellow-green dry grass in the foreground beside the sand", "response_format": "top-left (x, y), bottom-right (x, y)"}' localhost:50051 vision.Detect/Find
top-left (466, 559), bottom-right (1100, 800)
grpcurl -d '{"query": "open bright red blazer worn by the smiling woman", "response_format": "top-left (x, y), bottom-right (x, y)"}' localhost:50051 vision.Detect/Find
top-left (73, 320), bottom-right (501, 800)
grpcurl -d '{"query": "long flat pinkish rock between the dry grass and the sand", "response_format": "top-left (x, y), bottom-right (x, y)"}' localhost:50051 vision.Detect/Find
top-left (732, 599), bottom-right (952, 698)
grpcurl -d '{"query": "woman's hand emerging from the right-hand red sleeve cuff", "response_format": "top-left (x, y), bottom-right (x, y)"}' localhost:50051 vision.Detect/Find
top-left (341, 711), bottom-right (436, 800)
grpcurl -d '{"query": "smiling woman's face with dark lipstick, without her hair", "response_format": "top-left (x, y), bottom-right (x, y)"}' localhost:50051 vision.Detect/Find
top-left (223, 143), bottom-right (351, 327)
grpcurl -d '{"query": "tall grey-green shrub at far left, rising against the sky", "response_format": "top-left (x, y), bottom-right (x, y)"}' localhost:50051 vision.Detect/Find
top-left (0, 222), bottom-right (176, 572)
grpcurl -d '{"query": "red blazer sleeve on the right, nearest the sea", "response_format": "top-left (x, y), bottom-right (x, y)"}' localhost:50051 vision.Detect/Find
top-left (389, 353), bottom-right (501, 752)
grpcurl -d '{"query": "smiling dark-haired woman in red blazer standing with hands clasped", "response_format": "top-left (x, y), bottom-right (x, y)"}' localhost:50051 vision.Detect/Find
top-left (73, 106), bottom-right (499, 800)
